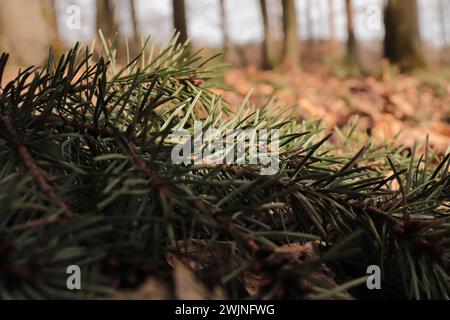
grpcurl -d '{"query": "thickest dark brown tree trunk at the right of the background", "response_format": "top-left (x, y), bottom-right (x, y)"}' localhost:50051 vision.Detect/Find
top-left (384, 0), bottom-right (425, 71)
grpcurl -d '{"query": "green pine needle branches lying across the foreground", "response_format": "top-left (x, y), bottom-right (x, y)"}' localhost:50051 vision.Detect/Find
top-left (0, 41), bottom-right (450, 299)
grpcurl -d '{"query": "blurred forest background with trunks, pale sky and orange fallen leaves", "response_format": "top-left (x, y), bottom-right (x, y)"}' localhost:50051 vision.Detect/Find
top-left (0, 0), bottom-right (450, 153)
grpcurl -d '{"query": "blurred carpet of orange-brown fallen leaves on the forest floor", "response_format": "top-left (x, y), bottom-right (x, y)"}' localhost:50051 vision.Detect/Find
top-left (214, 65), bottom-right (450, 153)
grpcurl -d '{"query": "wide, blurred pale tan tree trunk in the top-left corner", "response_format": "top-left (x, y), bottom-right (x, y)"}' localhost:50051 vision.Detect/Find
top-left (0, 0), bottom-right (57, 65)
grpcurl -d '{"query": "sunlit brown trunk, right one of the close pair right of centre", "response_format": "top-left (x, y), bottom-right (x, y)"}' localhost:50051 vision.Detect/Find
top-left (282, 0), bottom-right (300, 68)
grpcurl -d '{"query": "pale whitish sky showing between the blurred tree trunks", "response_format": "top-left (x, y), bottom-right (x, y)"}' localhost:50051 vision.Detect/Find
top-left (57, 0), bottom-right (450, 46)
